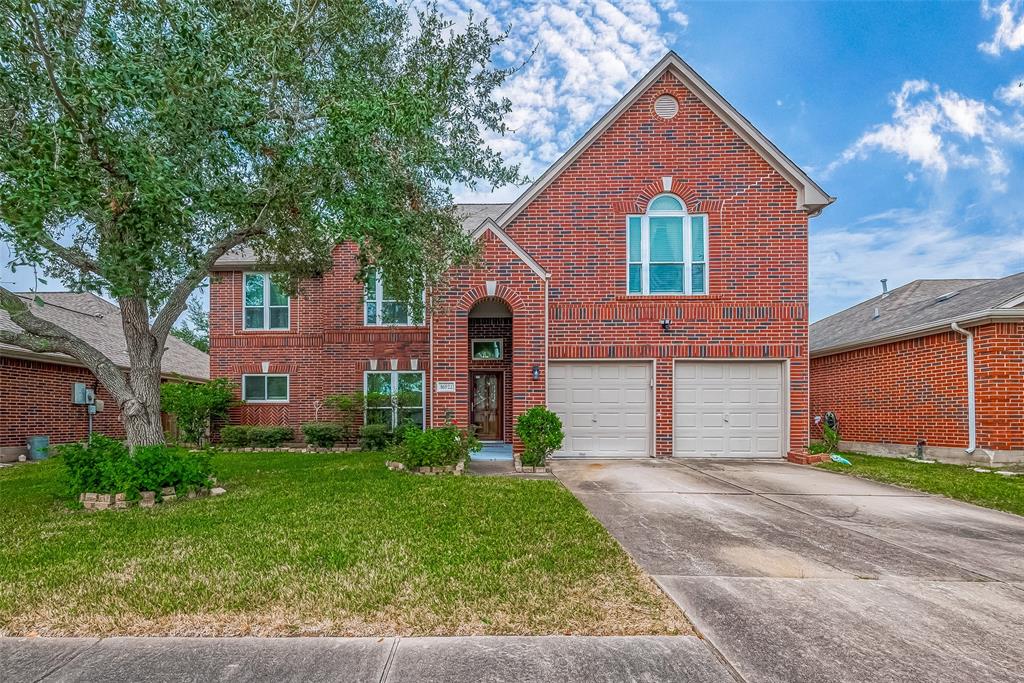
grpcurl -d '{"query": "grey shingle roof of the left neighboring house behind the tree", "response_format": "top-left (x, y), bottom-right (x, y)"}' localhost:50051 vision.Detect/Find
top-left (0, 292), bottom-right (210, 380)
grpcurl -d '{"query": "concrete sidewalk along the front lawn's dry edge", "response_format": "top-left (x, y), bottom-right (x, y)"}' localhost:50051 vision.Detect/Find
top-left (0, 636), bottom-right (734, 683)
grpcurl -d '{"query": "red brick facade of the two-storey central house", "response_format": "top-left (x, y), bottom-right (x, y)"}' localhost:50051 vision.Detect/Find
top-left (211, 68), bottom-right (809, 456)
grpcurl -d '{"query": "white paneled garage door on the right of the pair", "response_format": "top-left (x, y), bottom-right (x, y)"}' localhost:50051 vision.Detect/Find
top-left (673, 360), bottom-right (785, 458)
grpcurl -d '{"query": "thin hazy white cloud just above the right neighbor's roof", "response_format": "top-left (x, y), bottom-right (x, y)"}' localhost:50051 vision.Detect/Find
top-left (810, 209), bottom-right (1024, 319)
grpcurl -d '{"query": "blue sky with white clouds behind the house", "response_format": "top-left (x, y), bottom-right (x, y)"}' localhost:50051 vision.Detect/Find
top-left (0, 0), bottom-right (1024, 319)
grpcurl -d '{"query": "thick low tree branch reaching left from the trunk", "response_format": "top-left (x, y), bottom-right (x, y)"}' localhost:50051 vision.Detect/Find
top-left (0, 287), bottom-right (131, 402)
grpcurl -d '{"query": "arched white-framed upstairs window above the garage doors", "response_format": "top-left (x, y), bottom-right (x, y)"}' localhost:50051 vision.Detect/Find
top-left (627, 195), bottom-right (708, 294)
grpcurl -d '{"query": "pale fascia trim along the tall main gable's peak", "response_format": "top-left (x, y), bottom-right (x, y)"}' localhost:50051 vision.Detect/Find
top-left (498, 51), bottom-right (836, 225)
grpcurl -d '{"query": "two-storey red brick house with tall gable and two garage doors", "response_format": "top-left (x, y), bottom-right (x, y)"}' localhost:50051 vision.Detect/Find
top-left (210, 53), bottom-right (834, 461)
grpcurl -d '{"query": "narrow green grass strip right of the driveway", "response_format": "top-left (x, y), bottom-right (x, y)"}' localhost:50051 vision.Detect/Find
top-left (817, 453), bottom-right (1024, 515)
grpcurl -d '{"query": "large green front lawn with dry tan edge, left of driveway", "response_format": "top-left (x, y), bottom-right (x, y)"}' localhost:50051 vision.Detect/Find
top-left (0, 454), bottom-right (689, 636)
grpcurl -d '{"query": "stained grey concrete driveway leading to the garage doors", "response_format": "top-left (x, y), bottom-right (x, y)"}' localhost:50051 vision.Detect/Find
top-left (553, 460), bottom-right (1024, 682)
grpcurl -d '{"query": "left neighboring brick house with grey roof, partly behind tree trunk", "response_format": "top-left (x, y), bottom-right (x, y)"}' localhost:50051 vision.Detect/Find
top-left (0, 292), bottom-right (210, 462)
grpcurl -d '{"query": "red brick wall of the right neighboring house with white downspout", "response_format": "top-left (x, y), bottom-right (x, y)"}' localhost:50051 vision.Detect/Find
top-left (811, 323), bottom-right (1024, 451)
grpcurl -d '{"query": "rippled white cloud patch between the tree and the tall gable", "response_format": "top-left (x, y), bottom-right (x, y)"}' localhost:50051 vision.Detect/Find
top-left (439, 0), bottom-right (689, 202)
